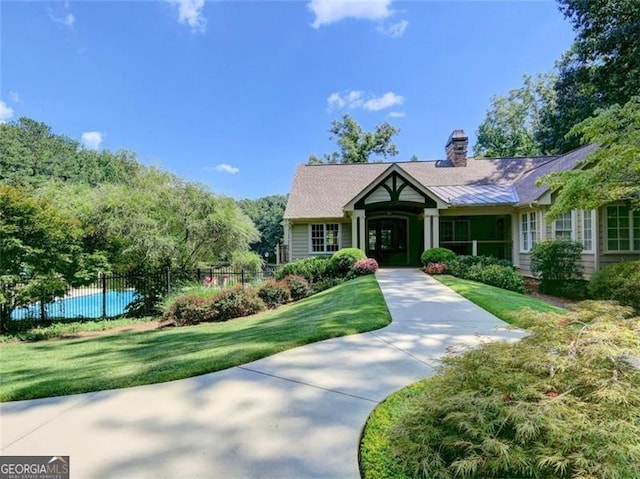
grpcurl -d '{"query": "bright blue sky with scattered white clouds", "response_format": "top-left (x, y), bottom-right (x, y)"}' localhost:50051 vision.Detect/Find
top-left (0, 0), bottom-right (574, 199)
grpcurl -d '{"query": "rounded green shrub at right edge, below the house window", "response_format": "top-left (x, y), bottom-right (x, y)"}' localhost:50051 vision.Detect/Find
top-left (589, 261), bottom-right (640, 313)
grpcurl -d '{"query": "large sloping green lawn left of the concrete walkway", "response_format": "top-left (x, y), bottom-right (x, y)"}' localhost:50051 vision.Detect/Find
top-left (0, 276), bottom-right (391, 401)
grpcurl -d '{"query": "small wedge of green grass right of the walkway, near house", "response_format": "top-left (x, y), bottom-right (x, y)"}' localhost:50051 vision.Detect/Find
top-left (433, 275), bottom-right (566, 326)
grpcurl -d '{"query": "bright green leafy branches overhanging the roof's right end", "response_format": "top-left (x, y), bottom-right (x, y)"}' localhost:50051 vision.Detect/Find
top-left (541, 97), bottom-right (640, 218)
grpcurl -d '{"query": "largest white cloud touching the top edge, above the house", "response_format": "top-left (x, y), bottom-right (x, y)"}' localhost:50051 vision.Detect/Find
top-left (307, 0), bottom-right (393, 28)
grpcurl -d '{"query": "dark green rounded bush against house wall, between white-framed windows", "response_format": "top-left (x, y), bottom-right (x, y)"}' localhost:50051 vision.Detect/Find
top-left (531, 240), bottom-right (583, 296)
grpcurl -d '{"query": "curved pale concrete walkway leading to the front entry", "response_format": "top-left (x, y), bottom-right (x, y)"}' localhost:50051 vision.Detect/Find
top-left (0, 269), bottom-right (520, 479)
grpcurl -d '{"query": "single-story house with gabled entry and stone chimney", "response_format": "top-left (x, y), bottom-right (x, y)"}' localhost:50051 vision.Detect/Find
top-left (282, 130), bottom-right (640, 276)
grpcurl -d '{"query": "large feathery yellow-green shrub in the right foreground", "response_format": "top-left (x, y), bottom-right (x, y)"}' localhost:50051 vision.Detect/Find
top-left (389, 302), bottom-right (640, 478)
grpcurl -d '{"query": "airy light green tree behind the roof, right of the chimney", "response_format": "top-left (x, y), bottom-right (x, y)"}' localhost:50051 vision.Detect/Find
top-left (474, 75), bottom-right (555, 157)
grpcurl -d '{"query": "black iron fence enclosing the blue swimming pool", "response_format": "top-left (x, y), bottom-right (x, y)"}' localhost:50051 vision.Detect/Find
top-left (11, 266), bottom-right (276, 321)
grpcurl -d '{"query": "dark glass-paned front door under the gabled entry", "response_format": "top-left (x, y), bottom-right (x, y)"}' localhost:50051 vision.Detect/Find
top-left (367, 218), bottom-right (409, 266)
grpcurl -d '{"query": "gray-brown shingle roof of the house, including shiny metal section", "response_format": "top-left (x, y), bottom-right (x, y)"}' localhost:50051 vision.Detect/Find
top-left (284, 146), bottom-right (596, 219)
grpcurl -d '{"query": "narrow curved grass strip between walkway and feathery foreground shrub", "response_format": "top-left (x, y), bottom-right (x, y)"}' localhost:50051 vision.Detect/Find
top-left (360, 380), bottom-right (429, 479)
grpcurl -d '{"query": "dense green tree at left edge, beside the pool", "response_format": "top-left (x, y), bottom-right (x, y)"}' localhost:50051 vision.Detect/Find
top-left (0, 185), bottom-right (104, 331)
